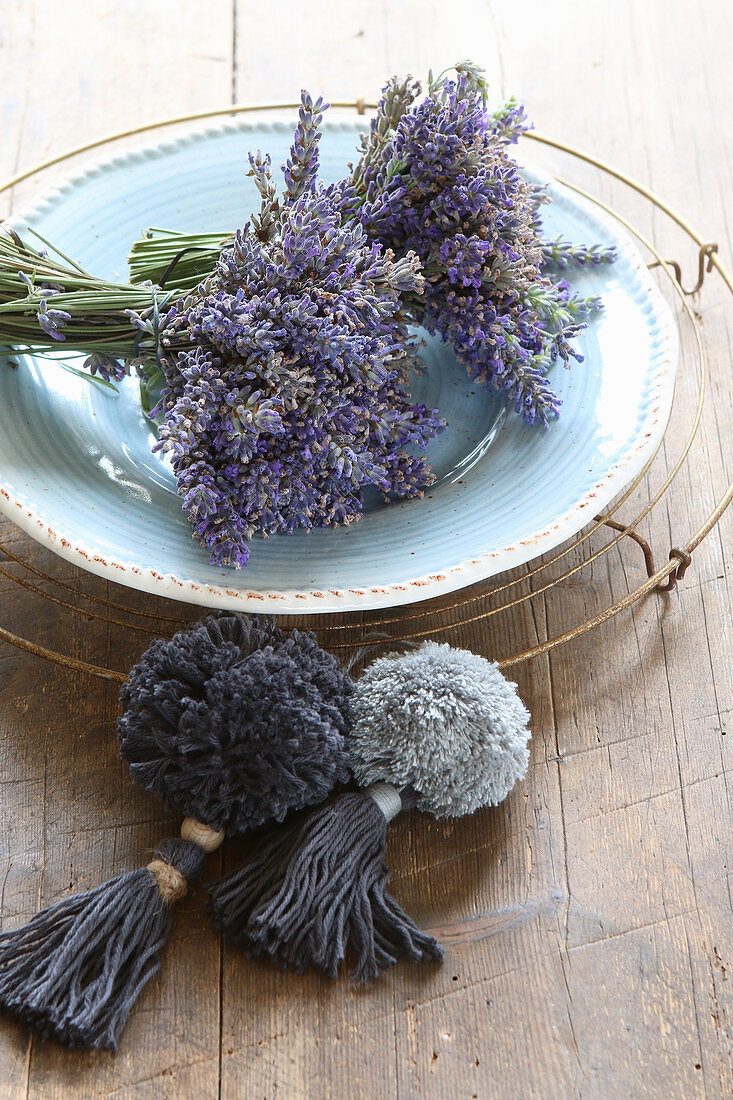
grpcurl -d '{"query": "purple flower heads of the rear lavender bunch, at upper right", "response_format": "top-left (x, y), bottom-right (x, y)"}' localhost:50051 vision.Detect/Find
top-left (332, 63), bottom-right (612, 425)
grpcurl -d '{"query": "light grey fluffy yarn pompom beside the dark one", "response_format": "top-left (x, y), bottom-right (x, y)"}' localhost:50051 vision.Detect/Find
top-left (349, 641), bottom-right (529, 817)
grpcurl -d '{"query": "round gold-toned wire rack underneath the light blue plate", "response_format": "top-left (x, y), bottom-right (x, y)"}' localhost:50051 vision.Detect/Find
top-left (0, 100), bottom-right (733, 683)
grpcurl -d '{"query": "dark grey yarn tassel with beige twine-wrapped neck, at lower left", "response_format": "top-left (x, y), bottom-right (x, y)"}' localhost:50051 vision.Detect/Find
top-left (0, 839), bottom-right (206, 1051)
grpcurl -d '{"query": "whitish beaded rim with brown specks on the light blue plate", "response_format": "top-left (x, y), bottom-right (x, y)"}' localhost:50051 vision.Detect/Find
top-left (0, 125), bottom-right (679, 615)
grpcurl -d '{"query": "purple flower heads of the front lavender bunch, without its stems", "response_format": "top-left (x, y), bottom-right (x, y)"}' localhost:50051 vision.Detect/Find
top-left (149, 94), bottom-right (445, 565)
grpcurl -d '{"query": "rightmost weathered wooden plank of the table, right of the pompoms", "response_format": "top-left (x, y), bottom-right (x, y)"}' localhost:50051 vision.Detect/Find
top-left (488, 4), bottom-right (733, 1096)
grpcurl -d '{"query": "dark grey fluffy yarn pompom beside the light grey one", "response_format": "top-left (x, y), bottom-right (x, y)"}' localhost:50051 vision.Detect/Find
top-left (118, 614), bottom-right (352, 834)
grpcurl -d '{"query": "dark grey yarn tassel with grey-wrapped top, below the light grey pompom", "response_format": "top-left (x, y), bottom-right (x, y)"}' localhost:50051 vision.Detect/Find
top-left (208, 783), bottom-right (442, 980)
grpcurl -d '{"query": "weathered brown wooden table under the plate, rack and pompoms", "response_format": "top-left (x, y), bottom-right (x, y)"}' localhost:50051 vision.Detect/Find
top-left (0, 0), bottom-right (733, 1100)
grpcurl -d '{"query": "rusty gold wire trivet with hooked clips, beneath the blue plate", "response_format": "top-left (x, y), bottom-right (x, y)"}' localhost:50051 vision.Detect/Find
top-left (0, 107), bottom-right (733, 683)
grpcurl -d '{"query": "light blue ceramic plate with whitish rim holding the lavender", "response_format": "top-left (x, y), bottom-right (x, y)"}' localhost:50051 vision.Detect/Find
top-left (0, 123), bottom-right (677, 613)
